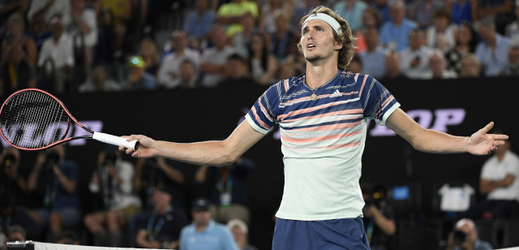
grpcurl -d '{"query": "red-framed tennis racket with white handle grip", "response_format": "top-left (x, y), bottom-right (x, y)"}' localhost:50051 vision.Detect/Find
top-left (0, 88), bottom-right (139, 150)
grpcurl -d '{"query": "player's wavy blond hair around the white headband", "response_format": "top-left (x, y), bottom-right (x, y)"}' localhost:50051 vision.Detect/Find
top-left (297, 6), bottom-right (357, 70)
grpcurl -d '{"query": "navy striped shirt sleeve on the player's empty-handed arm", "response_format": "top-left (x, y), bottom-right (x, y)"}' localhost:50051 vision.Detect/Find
top-left (357, 75), bottom-right (400, 125)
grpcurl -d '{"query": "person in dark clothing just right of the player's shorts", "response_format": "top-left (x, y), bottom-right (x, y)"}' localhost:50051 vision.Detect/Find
top-left (362, 184), bottom-right (396, 250)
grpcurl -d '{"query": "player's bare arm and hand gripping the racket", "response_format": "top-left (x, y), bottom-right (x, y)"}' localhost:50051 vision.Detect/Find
top-left (119, 121), bottom-right (263, 165)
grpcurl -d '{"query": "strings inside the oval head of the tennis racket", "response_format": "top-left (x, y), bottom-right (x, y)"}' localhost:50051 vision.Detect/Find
top-left (0, 90), bottom-right (70, 149)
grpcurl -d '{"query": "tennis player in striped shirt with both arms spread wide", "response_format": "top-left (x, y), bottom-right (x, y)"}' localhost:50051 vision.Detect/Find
top-left (124, 6), bottom-right (508, 249)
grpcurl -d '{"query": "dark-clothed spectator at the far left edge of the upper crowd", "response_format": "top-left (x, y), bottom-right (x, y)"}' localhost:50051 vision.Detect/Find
top-left (2, 13), bottom-right (38, 65)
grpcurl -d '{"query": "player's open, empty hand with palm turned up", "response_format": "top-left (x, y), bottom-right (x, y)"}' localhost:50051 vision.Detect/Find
top-left (467, 122), bottom-right (508, 155)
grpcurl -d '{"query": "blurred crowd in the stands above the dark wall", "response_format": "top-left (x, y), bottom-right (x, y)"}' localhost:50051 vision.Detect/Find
top-left (0, 0), bottom-right (519, 95)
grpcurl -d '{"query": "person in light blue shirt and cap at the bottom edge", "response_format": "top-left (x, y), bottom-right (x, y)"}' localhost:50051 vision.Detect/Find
top-left (180, 198), bottom-right (238, 250)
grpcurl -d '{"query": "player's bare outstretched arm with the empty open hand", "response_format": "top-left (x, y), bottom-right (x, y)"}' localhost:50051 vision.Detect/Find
top-left (386, 108), bottom-right (508, 155)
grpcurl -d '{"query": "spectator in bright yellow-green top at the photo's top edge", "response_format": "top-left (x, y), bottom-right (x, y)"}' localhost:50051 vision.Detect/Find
top-left (216, 0), bottom-right (259, 36)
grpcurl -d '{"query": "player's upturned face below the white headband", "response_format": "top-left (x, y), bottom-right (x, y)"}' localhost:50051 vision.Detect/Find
top-left (301, 20), bottom-right (342, 63)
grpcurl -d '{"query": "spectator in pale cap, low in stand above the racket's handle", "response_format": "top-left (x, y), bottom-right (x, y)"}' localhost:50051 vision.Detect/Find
top-left (123, 56), bottom-right (155, 90)
